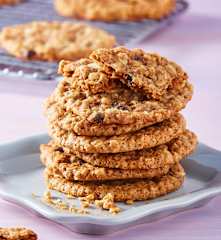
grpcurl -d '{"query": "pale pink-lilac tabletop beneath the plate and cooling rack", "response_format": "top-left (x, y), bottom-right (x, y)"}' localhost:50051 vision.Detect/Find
top-left (0, 0), bottom-right (221, 240)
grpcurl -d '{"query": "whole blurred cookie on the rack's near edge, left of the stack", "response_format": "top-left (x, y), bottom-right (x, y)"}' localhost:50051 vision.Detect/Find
top-left (0, 21), bottom-right (115, 61)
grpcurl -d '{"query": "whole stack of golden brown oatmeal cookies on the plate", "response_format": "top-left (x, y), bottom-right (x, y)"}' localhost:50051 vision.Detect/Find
top-left (41, 47), bottom-right (197, 206)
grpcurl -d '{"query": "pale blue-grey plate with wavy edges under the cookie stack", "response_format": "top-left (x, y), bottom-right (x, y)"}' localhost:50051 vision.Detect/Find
top-left (0, 135), bottom-right (221, 234)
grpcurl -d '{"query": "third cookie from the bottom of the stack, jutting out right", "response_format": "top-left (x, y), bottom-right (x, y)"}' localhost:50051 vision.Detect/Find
top-left (61, 130), bottom-right (197, 169)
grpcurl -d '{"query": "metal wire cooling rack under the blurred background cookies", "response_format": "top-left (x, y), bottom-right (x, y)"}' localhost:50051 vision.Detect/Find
top-left (0, 0), bottom-right (188, 80)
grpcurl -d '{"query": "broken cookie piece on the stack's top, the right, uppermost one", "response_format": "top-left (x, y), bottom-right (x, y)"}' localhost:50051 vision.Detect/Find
top-left (90, 47), bottom-right (188, 99)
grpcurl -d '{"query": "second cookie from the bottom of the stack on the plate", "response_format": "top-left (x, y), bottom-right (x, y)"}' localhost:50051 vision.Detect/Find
top-left (41, 144), bottom-right (170, 181)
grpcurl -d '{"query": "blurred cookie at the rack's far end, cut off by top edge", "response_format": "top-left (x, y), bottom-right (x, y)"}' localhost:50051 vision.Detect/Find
top-left (54, 0), bottom-right (176, 21)
